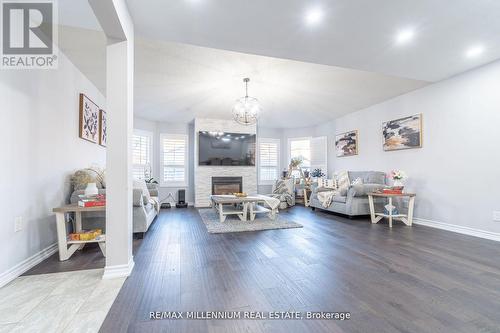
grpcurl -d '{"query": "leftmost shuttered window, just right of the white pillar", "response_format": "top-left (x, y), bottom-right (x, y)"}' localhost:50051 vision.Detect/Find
top-left (132, 130), bottom-right (153, 179)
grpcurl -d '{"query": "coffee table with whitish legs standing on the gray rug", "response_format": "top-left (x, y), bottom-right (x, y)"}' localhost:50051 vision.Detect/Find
top-left (210, 195), bottom-right (278, 223)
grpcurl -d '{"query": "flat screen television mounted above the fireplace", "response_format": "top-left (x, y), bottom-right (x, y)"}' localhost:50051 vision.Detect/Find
top-left (198, 131), bottom-right (256, 166)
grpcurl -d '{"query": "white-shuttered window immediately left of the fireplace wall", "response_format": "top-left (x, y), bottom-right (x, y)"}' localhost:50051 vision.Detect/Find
top-left (160, 134), bottom-right (188, 186)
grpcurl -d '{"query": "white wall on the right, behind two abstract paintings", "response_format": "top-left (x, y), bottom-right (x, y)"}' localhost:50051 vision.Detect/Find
top-left (330, 61), bottom-right (500, 233)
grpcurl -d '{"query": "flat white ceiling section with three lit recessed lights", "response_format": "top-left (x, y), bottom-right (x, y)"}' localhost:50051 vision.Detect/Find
top-left (127, 0), bottom-right (500, 81)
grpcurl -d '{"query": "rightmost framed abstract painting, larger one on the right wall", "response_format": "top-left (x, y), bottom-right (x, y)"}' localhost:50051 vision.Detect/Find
top-left (382, 114), bottom-right (422, 151)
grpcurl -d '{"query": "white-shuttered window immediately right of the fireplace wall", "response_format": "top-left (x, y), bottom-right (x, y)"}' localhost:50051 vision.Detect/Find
top-left (259, 139), bottom-right (280, 185)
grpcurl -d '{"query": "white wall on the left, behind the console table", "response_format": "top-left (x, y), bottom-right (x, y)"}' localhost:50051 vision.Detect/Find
top-left (0, 52), bottom-right (106, 278)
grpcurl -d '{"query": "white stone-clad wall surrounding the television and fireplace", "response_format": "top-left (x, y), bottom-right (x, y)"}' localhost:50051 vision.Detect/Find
top-left (194, 118), bottom-right (257, 207)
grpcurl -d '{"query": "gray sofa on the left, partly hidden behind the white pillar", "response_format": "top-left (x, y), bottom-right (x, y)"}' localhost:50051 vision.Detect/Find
top-left (70, 183), bottom-right (159, 237)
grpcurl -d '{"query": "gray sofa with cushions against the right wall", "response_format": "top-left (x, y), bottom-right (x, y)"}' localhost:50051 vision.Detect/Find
top-left (310, 171), bottom-right (387, 217)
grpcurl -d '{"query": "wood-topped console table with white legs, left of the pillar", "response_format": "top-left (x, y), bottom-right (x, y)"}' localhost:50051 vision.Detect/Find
top-left (52, 204), bottom-right (106, 261)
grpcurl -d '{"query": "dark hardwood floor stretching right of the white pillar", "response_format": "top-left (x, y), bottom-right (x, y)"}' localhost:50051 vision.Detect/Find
top-left (97, 207), bottom-right (500, 333)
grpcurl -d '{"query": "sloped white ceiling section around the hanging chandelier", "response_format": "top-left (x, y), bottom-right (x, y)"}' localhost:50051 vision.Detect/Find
top-left (134, 40), bottom-right (426, 128)
